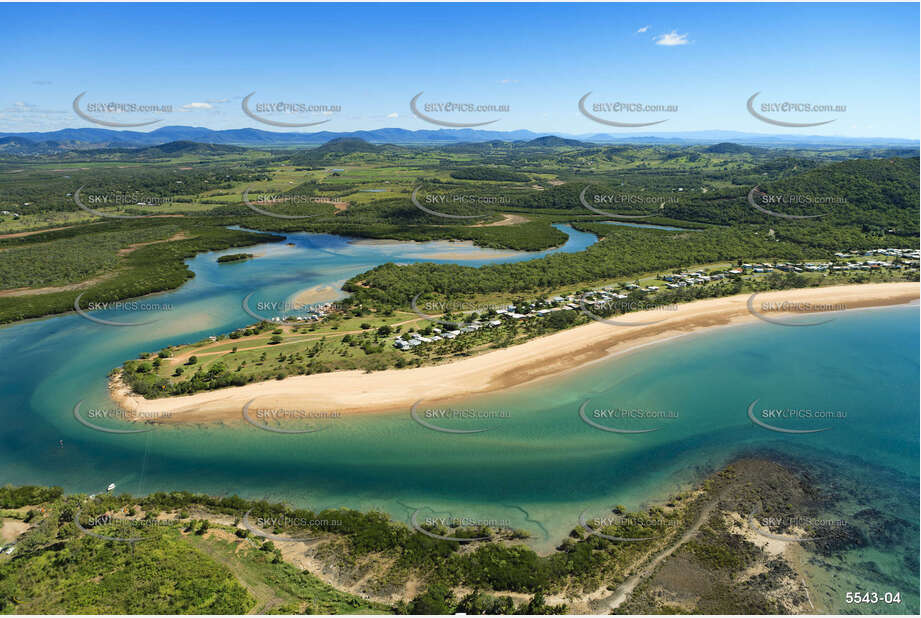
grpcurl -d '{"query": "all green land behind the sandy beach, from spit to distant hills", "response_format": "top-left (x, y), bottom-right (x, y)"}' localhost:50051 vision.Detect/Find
top-left (0, 138), bottom-right (919, 397)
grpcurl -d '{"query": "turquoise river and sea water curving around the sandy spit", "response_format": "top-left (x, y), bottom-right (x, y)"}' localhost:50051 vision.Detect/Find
top-left (0, 228), bottom-right (918, 608)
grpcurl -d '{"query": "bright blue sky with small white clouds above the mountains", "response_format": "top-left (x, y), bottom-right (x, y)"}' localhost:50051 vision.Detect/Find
top-left (0, 3), bottom-right (919, 139)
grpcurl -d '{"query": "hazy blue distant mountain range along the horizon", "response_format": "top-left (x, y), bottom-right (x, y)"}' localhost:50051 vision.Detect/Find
top-left (0, 126), bottom-right (919, 154)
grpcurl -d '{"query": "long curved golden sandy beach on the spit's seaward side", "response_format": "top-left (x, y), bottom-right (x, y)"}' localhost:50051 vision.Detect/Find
top-left (110, 282), bottom-right (921, 422)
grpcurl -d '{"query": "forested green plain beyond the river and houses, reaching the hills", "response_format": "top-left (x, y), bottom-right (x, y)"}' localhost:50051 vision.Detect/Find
top-left (0, 138), bottom-right (918, 323)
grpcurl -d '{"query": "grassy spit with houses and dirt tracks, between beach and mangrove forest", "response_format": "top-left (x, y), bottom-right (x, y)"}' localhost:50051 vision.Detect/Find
top-left (114, 261), bottom-right (918, 398)
